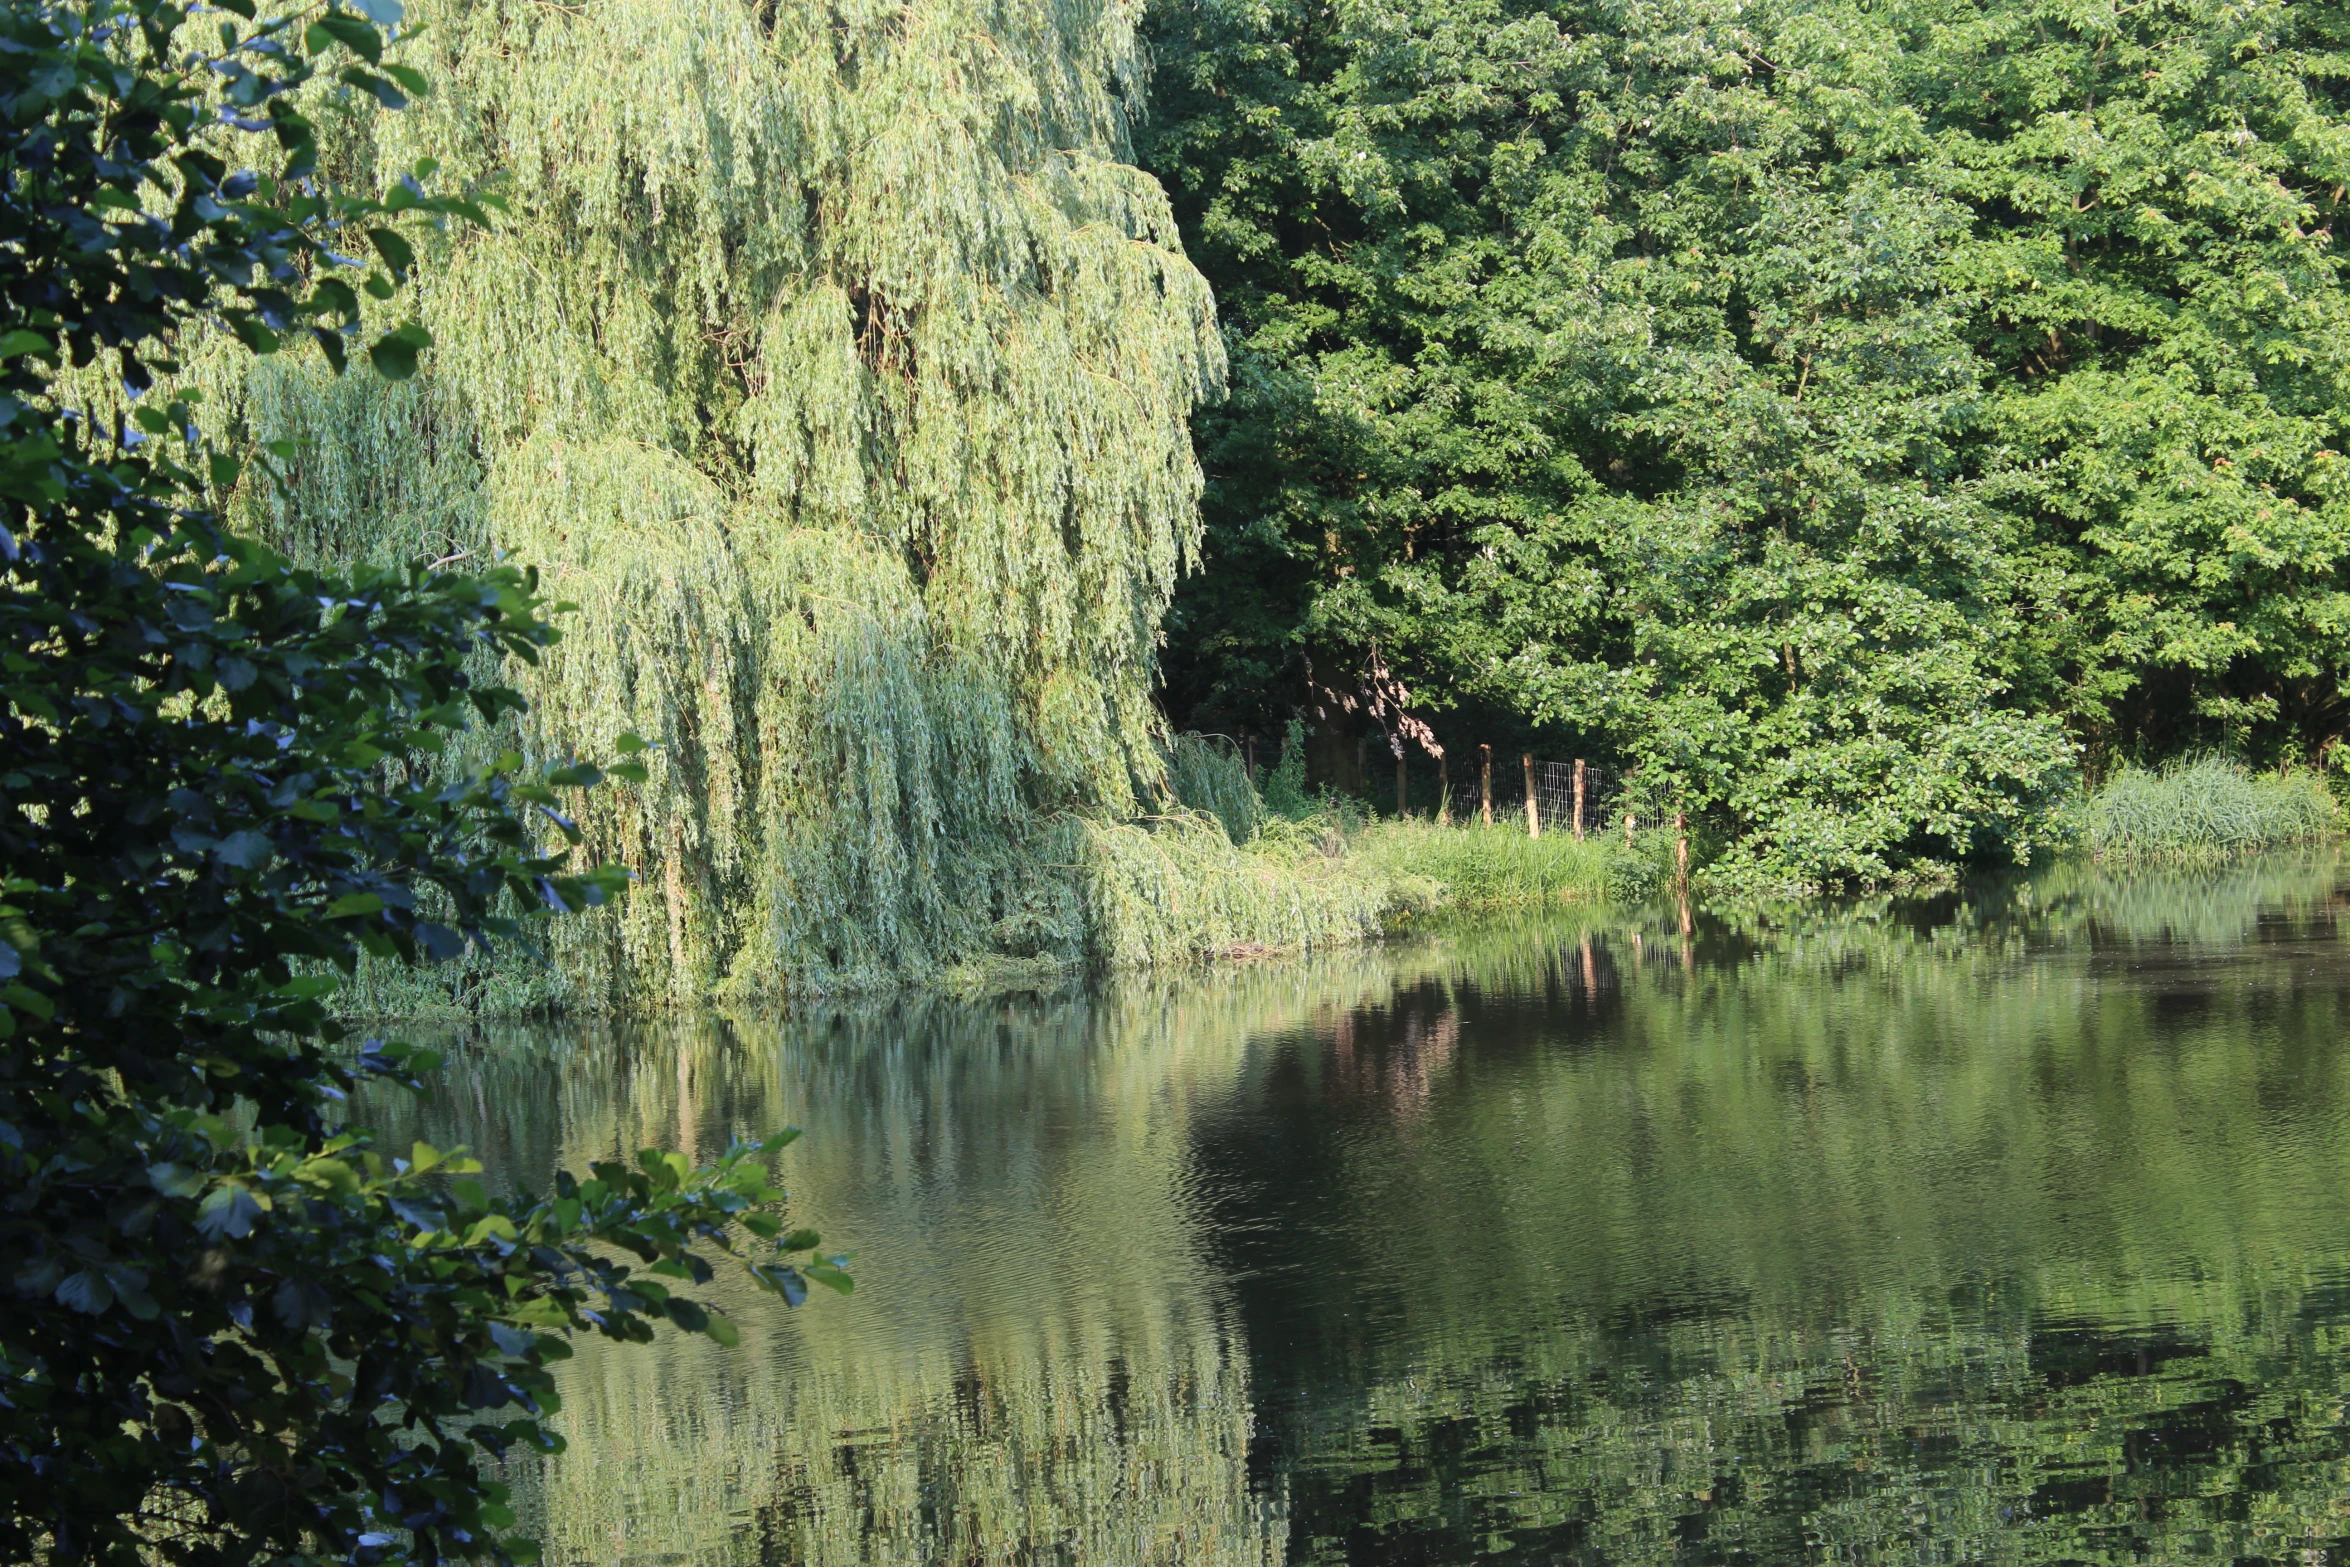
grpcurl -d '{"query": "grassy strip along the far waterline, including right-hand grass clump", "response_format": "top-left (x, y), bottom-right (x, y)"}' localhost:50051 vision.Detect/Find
top-left (343, 742), bottom-right (2338, 1017)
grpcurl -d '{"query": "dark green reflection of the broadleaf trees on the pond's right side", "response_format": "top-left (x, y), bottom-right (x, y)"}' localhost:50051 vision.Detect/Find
top-left (1236, 867), bottom-right (2350, 1560)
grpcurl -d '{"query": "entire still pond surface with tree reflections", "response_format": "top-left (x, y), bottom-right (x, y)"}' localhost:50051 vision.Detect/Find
top-left (378, 862), bottom-right (2350, 1567)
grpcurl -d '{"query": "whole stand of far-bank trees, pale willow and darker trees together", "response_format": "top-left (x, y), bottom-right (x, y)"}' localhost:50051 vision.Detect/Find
top-left (137, 0), bottom-right (2350, 1003)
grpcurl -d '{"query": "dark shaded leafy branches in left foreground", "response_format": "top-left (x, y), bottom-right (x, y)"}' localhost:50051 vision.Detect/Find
top-left (0, 0), bottom-right (846, 1567)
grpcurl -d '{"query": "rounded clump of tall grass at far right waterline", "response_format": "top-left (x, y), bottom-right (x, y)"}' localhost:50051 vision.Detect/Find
top-left (2087, 756), bottom-right (2338, 860)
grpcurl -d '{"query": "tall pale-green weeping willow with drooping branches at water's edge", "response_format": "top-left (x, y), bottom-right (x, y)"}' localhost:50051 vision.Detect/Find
top-left (188, 0), bottom-right (1377, 1001)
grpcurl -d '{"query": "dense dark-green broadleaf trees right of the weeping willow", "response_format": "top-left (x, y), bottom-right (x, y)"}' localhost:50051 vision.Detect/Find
top-left (1144, 0), bottom-right (2350, 883)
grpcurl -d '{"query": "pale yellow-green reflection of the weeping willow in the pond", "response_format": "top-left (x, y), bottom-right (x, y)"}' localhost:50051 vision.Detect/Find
top-left (376, 954), bottom-right (1428, 1562)
